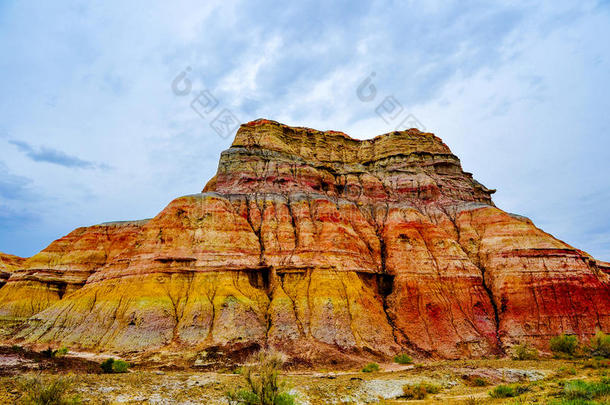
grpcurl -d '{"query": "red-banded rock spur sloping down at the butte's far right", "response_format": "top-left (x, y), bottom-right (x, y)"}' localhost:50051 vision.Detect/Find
top-left (444, 207), bottom-right (610, 347)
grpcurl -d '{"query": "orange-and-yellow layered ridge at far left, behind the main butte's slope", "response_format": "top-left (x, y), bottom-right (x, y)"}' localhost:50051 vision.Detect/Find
top-left (0, 221), bottom-right (146, 318)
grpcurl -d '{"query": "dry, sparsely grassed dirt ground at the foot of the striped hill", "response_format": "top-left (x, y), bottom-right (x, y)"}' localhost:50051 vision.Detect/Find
top-left (0, 349), bottom-right (610, 405)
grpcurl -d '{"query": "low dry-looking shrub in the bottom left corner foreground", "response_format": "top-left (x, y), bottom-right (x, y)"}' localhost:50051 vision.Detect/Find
top-left (18, 377), bottom-right (81, 405)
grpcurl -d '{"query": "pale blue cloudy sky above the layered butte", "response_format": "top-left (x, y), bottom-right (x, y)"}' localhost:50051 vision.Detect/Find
top-left (0, 0), bottom-right (610, 261)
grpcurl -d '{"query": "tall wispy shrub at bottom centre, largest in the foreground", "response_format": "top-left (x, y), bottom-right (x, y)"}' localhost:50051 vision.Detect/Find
top-left (226, 351), bottom-right (294, 405)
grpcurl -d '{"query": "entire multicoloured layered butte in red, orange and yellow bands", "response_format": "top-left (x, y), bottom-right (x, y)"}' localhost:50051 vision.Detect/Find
top-left (0, 120), bottom-right (610, 362)
